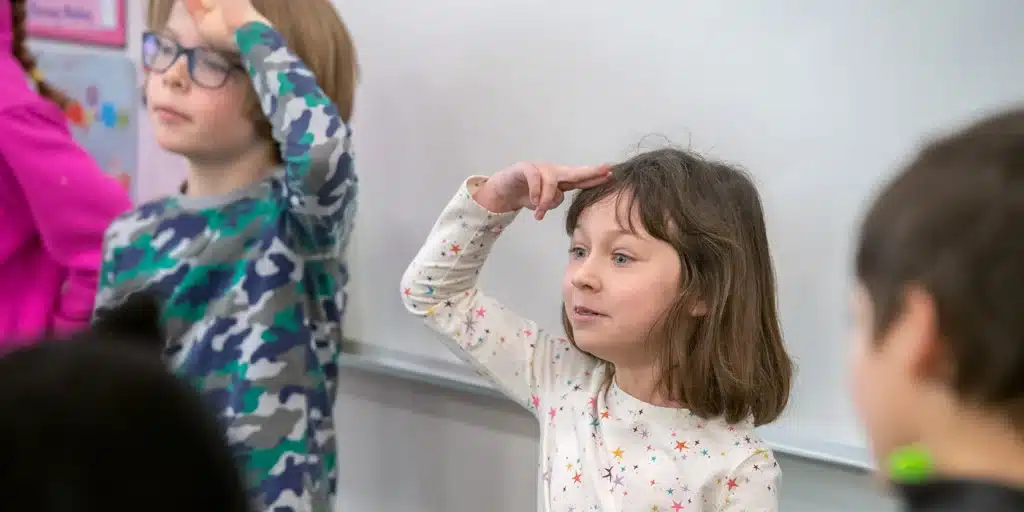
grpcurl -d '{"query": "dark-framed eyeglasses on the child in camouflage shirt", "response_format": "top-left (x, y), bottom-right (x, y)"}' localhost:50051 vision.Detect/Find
top-left (142, 32), bottom-right (245, 89)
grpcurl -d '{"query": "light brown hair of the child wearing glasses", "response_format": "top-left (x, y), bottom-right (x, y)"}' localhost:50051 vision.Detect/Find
top-left (145, 0), bottom-right (358, 163)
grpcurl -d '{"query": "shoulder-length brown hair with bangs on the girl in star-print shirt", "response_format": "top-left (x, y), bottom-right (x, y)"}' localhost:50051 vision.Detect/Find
top-left (562, 148), bottom-right (793, 425)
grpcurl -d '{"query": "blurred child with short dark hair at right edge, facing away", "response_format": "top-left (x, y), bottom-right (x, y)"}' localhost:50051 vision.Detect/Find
top-left (854, 105), bottom-right (1024, 512)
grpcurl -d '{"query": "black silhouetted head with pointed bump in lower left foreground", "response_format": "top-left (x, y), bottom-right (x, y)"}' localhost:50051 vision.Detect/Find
top-left (0, 300), bottom-right (249, 512)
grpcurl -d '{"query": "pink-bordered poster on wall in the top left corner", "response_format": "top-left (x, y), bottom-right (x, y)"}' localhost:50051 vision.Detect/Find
top-left (28, 0), bottom-right (126, 48)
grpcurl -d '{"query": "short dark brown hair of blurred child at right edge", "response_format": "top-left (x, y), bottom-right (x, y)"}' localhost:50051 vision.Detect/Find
top-left (856, 105), bottom-right (1024, 429)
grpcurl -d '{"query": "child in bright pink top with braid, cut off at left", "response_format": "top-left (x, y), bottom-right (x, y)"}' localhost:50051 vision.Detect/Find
top-left (0, 0), bottom-right (131, 349)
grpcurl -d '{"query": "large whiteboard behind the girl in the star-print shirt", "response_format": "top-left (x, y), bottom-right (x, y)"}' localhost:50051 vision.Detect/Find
top-left (337, 0), bottom-right (1024, 467)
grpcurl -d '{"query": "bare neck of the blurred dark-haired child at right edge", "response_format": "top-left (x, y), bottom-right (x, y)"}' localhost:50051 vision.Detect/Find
top-left (922, 399), bottom-right (1024, 488)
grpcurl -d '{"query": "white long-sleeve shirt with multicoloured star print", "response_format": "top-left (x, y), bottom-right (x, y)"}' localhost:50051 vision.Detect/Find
top-left (402, 176), bottom-right (779, 512)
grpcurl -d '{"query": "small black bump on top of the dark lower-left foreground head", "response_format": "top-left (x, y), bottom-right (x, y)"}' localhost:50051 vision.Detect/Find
top-left (89, 294), bottom-right (164, 350)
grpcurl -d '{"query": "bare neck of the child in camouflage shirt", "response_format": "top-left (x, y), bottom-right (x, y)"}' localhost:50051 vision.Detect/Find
top-left (187, 144), bottom-right (274, 196)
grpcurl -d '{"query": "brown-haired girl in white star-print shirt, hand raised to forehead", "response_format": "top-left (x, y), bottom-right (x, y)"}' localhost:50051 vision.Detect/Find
top-left (402, 150), bottom-right (792, 512)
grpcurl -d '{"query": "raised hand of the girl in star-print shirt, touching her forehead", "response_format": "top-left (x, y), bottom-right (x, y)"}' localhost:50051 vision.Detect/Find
top-left (473, 163), bottom-right (611, 220)
